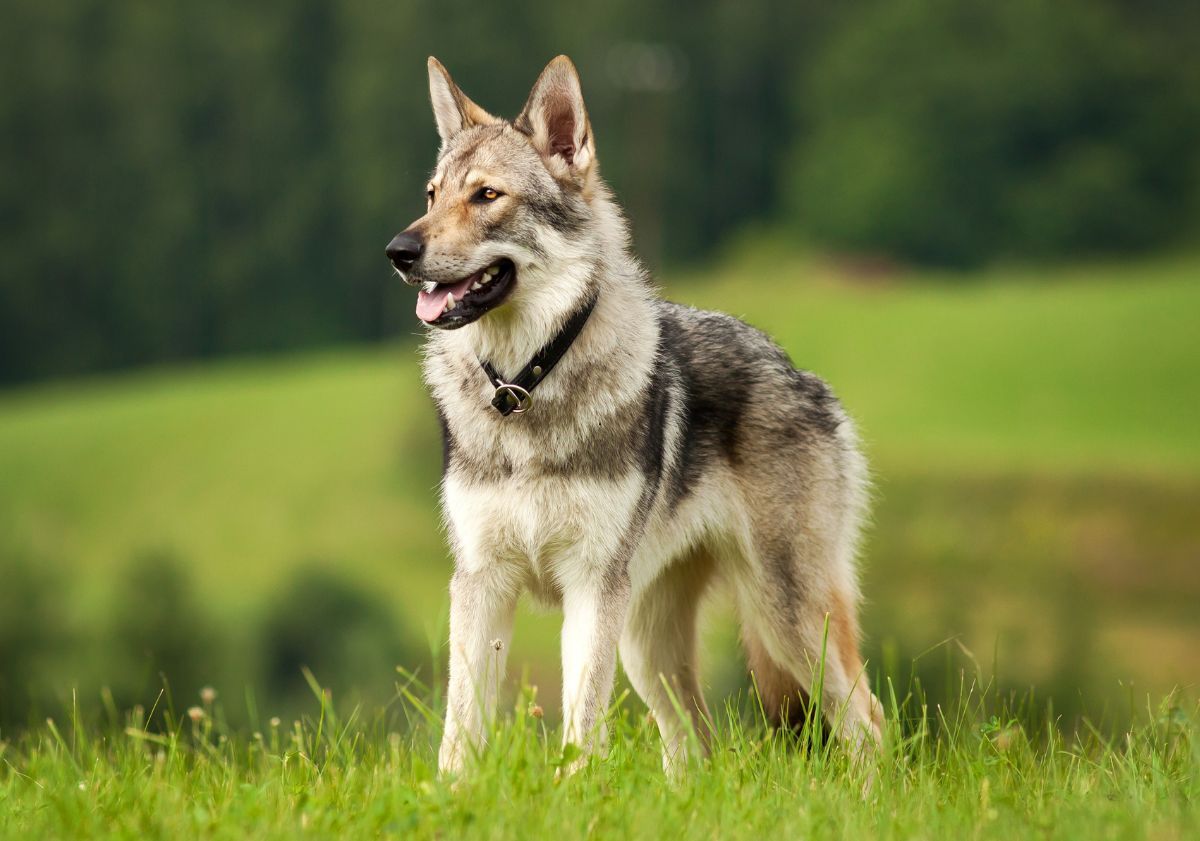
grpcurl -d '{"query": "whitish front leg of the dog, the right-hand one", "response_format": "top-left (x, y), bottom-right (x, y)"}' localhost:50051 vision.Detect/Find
top-left (563, 566), bottom-right (630, 773)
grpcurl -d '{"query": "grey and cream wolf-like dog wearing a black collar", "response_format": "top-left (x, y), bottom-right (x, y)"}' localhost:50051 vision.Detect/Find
top-left (386, 55), bottom-right (882, 774)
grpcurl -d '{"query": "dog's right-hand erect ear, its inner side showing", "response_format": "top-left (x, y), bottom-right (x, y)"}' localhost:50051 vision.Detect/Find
top-left (515, 55), bottom-right (595, 175)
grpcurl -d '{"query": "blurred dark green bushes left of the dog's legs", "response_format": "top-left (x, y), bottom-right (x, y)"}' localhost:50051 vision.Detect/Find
top-left (0, 552), bottom-right (430, 733)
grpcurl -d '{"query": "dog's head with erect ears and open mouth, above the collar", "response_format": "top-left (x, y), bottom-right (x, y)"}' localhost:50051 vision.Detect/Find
top-left (386, 55), bottom-right (598, 329)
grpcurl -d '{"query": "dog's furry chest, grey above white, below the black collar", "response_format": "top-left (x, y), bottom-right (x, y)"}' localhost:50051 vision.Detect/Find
top-left (427, 328), bottom-right (646, 583)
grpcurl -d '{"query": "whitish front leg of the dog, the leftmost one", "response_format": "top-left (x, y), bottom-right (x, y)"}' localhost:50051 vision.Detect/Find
top-left (438, 569), bottom-right (520, 774)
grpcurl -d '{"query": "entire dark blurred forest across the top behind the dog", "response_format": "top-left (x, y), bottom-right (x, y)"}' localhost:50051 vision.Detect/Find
top-left (0, 0), bottom-right (1200, 382)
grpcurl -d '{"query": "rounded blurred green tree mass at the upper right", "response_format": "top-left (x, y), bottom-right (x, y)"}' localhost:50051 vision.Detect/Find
top-left (792, 0), bottom-right (1200, 265)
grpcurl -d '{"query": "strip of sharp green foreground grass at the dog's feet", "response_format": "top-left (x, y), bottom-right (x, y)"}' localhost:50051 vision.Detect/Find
top-left (0, 687), bottom-right (1200, 840)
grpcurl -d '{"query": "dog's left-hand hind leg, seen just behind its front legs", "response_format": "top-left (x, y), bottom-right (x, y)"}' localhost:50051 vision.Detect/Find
top-left (620, 551), bottom-right (713, 774)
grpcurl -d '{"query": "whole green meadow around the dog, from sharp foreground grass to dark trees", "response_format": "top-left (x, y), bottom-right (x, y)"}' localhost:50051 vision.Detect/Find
top-left (0, 253), bottom-right (1200, 837)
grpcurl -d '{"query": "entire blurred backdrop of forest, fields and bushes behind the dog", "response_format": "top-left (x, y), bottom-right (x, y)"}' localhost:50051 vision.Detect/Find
top-left (0, 0), bottom-right (1200, 735)
